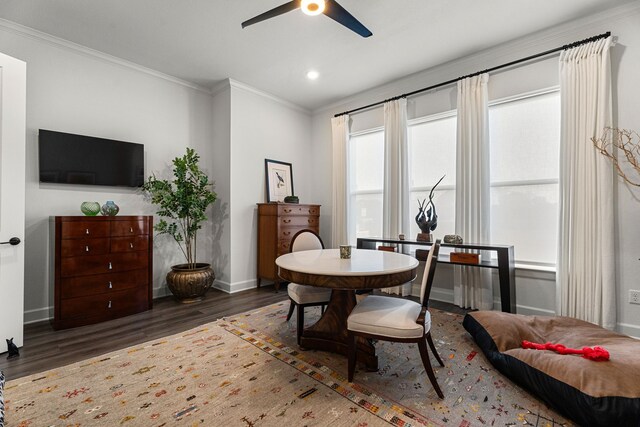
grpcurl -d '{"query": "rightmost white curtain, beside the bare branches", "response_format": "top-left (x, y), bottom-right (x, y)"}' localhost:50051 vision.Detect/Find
top-left (556, 37), bottom-right (616, 329)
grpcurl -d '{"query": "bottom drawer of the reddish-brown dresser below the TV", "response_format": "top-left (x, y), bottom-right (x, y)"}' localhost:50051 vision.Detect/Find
top-left (60, 287), bottom-right (149, 320)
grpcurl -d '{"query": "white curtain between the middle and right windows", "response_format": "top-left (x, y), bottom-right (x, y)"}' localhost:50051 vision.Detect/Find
top-left (453, 74), bottom-right (493, 310)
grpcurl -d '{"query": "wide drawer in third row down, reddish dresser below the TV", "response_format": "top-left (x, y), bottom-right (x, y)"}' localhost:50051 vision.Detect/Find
top-left (60, 252), bottom-right (149, 277)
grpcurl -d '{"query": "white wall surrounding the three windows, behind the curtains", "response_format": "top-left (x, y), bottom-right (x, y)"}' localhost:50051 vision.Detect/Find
top-left (311, 3), bottom-right (640, 336)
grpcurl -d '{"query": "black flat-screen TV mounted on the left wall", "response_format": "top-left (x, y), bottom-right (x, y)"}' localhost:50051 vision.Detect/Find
top-left (38, 129), bottom-right (144, 187)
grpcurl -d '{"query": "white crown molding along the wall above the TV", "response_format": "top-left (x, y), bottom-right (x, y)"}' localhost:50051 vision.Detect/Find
top-left (0, 18), bottom-right (211, 95)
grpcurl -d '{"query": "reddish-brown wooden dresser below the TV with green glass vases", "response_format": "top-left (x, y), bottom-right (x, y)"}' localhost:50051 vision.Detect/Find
top-left (50, 216), bottom-right (153, 329)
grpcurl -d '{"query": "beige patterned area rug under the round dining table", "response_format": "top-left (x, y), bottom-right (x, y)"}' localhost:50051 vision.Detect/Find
top-left (5, 302), bottom-right (571, 427)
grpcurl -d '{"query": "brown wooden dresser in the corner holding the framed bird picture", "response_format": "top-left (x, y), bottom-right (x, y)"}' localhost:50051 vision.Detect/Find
top-left (258, 203), bottom-right (320, 290)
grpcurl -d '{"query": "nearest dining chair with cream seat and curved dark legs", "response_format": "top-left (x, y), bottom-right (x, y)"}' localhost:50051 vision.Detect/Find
top-left (347, 240), bottom-right (444, 399)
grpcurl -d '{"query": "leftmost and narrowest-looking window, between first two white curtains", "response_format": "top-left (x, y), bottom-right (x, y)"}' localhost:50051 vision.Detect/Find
top-left (349, 129), bottom-right (384, 245)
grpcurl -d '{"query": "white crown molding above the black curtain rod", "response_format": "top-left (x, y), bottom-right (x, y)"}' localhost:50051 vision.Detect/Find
top-left (311, 2), bottom-right (640, 115)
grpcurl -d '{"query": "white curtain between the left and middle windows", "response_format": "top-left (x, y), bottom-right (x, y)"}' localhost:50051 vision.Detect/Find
top-left (382, 98), bottom-right (411, 296)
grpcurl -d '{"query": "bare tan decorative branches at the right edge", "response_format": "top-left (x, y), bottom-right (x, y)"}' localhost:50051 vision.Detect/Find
top-left (591, 127), bottom-right (640, 187)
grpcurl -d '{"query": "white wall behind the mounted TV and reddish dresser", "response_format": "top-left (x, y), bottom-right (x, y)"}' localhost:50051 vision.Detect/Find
top-left (0, 20), bottom-right (213, 322)
